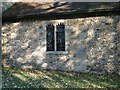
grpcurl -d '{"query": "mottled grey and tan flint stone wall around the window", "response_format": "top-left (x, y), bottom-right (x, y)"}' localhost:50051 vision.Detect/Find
top-left (2, 16), bottom-right (120, 74)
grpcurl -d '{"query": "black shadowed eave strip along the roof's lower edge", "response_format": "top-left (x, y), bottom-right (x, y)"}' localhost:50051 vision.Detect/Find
top-left (2, 8), bottom-right (120, 23)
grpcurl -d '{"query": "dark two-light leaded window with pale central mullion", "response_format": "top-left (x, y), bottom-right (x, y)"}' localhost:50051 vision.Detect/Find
top-left (46, 23), bottom-right (65, 51)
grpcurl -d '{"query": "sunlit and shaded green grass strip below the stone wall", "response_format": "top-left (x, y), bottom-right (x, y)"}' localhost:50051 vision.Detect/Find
top-left (2, 68), bottom-right (120, 88)
